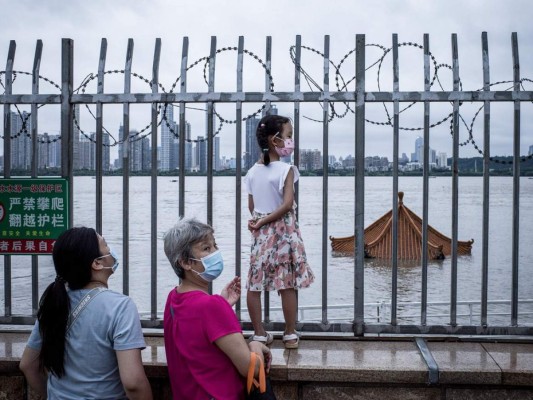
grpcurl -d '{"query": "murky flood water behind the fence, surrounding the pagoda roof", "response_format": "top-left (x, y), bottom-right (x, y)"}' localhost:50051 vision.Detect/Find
top-left (0, 177), bottom-right (533, 325)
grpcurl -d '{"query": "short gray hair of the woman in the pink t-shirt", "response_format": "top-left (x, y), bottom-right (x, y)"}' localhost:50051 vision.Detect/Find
top-left (163, 218), bottom-right (214, 279)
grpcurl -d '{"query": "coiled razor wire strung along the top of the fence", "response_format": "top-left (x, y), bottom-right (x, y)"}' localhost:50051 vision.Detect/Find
top-left (0, 42), bottom-right (533, 164)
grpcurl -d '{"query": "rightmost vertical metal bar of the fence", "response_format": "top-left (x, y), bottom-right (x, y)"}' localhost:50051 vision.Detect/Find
top-left (511, 32), bottom-right (520, 326)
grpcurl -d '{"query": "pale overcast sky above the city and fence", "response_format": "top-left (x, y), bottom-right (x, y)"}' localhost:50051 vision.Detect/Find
top-left (0, 0), bottom-right (533, 158)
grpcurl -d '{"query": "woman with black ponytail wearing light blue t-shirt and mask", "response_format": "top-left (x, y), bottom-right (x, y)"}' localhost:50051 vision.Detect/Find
top-left (20, 227), bottom-right (152, 400)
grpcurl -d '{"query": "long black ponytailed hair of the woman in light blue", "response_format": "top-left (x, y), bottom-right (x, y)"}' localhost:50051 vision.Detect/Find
top-left (37, 227), bottom-right (101, 378)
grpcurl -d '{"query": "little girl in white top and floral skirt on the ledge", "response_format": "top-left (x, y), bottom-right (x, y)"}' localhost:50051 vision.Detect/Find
top-left (244, 115), bottom-right (315, 349)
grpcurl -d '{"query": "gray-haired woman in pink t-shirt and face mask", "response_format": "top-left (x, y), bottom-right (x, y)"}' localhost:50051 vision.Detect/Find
top-left (163, 219), bottom-right (271, 400)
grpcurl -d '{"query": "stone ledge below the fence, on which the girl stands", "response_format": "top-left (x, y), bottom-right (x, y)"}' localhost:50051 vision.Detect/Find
top-left (0, 332), bottom-right (533, 400)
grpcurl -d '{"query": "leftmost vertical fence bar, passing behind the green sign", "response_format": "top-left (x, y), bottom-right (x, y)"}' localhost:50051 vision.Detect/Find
top-left (4, 40), bottom-right (17, 317)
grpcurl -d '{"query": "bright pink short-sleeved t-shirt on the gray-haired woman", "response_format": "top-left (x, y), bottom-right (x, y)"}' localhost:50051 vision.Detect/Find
top-left (163, 289), bottom-right (244, 400)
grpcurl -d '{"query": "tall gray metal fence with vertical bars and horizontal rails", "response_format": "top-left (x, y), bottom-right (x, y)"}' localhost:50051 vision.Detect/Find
top-left (0, 33), bottom-right (533, 336)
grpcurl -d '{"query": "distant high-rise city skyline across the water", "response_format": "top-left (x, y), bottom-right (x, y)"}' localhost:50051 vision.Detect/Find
top-left (2, 111), bottom-right (462, 173)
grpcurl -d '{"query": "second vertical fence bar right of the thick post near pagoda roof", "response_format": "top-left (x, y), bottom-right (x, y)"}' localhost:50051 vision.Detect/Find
top-left (420, 33), bottom-right (431, 325)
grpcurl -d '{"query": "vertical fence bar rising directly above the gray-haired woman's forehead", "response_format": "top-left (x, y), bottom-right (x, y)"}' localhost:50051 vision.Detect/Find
top-left (207, 36), bottom-right (217, 228)
